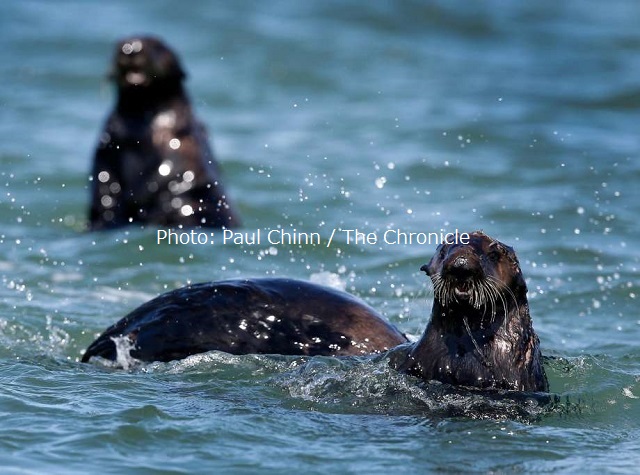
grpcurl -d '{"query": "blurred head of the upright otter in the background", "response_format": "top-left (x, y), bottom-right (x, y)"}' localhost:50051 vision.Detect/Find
top-left (111, 36), bottom-right (185, 88)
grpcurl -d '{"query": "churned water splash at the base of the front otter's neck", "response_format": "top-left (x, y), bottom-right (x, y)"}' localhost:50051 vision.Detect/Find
top-left (274, 357), bottom-right (551, 422)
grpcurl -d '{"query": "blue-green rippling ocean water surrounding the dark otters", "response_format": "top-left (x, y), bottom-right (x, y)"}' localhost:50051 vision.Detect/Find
top-left (0, 0), bottom-right (640, 474)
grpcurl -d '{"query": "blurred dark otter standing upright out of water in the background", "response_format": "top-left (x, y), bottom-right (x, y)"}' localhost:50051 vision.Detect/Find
top-left (89, 36), bottom-right (239, 229)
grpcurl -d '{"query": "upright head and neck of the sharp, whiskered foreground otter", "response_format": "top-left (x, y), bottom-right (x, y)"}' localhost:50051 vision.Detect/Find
top-left (392, 232), bottom-right (549, 392)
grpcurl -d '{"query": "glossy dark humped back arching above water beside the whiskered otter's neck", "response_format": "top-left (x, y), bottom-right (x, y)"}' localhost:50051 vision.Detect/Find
top-left (82, 278), bottom-right (407, 362)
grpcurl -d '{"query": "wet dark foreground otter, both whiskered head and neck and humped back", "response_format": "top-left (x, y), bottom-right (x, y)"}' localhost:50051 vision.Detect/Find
top-left (82, 232), bottom-right (548, 392)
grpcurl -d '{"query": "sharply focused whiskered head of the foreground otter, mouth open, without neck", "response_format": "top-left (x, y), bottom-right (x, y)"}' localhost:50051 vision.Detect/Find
top-left (420, 231), bottom-right (526, 309)
